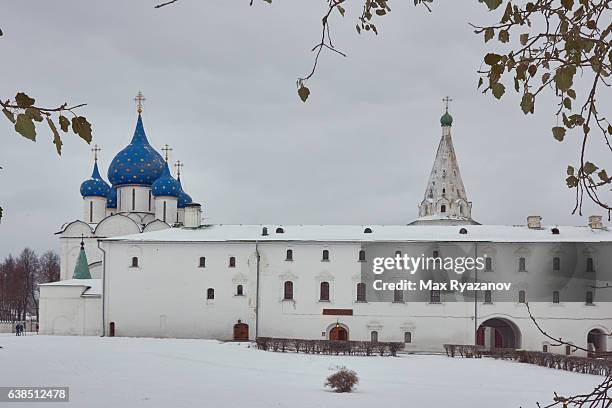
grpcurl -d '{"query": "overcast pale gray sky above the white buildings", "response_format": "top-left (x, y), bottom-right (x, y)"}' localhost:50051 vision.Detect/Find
top-left (0, 0), bottom-right (602, 256)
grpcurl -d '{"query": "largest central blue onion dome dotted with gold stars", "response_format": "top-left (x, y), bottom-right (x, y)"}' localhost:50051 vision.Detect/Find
top-left (108, 114), bottom-right (165, 187)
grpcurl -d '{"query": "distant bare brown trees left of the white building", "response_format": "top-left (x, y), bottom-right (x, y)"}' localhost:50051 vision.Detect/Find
top-left (0, 248), bottom-right (60, 322)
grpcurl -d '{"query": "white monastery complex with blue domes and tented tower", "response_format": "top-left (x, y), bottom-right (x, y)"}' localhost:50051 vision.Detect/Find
top-left (40, 100), bottom-right (612, 353)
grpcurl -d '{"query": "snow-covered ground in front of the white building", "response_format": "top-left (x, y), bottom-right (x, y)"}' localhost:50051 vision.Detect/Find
top-left (0, 335), bottom-right (602, 408)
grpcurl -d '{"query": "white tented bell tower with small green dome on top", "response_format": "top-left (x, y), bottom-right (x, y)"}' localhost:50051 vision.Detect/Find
top-left (413, 96), bottom-right (477, 225)
